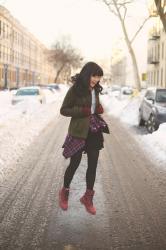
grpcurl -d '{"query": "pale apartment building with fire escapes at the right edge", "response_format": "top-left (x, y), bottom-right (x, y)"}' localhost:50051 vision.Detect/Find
top-left (147, 1), bottom-right (166, 88)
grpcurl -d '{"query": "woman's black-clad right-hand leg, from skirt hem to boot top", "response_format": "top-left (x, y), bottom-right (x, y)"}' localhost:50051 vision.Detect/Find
top-left (86, 149), bottom-right (99, 190)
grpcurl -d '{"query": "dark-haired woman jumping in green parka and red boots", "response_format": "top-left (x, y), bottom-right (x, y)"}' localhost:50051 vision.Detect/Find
top-left (59, 62), bottom-right (109, 214)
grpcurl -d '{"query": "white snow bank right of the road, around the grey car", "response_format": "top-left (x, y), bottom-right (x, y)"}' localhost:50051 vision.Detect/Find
top-left (101, 92), bottom-right (166, 168)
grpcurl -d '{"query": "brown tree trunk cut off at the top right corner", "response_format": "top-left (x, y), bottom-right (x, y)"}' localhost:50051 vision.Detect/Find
top-left (154, 0), bottom-right (166, 32)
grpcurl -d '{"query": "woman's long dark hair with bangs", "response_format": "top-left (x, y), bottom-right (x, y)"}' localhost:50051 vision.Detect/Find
top-left (72, 62), bottom-right (103, 96)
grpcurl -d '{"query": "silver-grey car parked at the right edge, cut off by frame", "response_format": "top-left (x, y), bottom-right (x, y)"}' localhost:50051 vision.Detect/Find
top-left (139, 88), bottom-right (166, 133)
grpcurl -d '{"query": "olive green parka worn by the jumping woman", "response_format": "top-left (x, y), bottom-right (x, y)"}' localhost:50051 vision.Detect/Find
top-left (60, 86), bottom-right (100, 139)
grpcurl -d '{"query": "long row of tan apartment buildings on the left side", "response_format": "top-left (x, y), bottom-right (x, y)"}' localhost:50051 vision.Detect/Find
top-left (0, 5), bottom-right (55, 88)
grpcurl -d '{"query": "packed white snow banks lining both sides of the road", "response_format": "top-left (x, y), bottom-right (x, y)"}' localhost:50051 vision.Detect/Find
top-left (0, 85), bottom-right (166, 180)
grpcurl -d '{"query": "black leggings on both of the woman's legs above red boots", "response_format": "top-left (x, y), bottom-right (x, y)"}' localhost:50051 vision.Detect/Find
top-left (64, 149), bottom-right (99, 190)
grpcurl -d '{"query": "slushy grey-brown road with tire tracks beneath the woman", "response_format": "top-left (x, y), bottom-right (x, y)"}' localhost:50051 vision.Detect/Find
top-left (0, 116), bottom-right (166, 250)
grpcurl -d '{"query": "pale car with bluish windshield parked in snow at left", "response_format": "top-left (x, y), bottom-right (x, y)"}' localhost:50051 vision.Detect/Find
top-left (12, 86), bottom-right (46, 105)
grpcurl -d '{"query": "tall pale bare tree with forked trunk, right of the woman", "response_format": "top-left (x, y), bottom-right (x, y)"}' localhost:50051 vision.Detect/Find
top-left (100, 0), bottom-right (150, 90)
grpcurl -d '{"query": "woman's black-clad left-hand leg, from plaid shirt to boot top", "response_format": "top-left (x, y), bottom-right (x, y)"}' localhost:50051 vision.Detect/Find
top-left (64, 151), bottom-right (82, 188)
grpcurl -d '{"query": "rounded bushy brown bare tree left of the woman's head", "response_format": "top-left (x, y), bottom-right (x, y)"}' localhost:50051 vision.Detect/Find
top-left (48, 37), bottom-right (82, 82)
